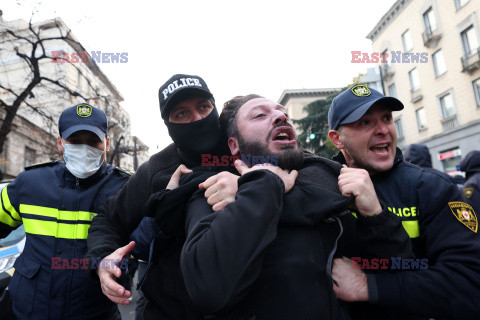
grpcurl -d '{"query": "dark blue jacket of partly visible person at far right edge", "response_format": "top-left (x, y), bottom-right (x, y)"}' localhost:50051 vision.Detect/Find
top-left (460, 150), bottom-right (480, 212)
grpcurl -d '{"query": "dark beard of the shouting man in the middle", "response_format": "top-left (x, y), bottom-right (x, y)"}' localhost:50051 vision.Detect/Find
top-left (237, 129), bottom-right (303, 170)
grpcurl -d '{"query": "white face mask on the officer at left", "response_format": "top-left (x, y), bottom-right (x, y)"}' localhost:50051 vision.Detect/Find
top-left (63, 143), bottom-right (103, 179)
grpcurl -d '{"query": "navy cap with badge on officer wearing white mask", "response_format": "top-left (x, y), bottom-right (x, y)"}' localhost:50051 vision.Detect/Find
top-left (58, 103), bottom-right (108, 140)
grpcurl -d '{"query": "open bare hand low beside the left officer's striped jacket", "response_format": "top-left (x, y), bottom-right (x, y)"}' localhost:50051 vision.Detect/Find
top-left (97, 241), bottom-right (135, 305)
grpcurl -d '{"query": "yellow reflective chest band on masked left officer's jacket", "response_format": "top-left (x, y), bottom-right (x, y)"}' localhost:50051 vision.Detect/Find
top-left (20, 204), bottom-right (97, 239)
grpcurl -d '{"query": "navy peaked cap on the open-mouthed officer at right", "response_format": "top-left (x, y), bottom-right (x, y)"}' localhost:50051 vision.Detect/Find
top-left (328, 84), bottom-right (403, 130)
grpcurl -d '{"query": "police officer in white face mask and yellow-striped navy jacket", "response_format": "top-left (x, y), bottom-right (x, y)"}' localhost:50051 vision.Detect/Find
top-left (0, 103), bottom-right (129, 320)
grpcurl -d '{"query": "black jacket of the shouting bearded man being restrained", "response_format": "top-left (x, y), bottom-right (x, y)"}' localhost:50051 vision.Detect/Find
top-left (181, 157), bottom-right (410, 320)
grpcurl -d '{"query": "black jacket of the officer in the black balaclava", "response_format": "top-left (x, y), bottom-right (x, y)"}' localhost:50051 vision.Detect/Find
top-left (86, 144), bottom-right (218, 320)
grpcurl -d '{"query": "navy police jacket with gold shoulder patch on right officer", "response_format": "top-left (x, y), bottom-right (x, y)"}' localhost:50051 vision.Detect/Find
top-left (336, 149), bottom-right (480, 320)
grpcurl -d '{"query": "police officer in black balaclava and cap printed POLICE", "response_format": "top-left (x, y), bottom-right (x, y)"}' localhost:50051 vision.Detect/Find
top-left (88, 74), bottom-right (238, 319)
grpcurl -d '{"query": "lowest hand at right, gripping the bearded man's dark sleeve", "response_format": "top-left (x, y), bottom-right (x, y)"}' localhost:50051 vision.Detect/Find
top-left (332, 257), bottom-right (369, 302)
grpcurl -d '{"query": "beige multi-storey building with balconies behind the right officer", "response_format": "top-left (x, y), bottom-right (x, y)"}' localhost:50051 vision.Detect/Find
top-left (367, 0), bottom-right (480, 174)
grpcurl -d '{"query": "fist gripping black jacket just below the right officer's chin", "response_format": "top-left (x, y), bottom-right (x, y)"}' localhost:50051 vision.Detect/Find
top-left (338, 165), bottom-right (382, 217)
